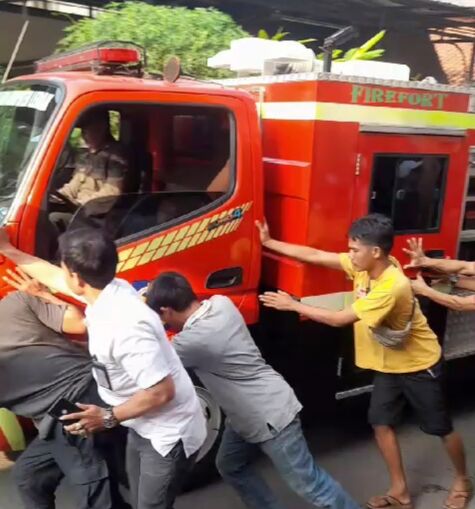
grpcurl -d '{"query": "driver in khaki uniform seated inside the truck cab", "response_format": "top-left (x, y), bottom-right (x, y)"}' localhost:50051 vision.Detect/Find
top-left (49, 108), bottom-right (129, 233)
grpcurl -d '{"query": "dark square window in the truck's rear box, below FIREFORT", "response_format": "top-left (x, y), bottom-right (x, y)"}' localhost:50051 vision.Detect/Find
top-left (370, 155), bottom-right (448, 233)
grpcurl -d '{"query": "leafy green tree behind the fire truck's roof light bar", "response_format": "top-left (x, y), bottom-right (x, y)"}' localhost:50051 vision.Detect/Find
top-left (58, 1), bottom-right (249, 78)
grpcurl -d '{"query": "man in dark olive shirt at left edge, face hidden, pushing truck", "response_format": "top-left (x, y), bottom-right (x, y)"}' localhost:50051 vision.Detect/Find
top-left (0, 272), bottom-right (128, 509)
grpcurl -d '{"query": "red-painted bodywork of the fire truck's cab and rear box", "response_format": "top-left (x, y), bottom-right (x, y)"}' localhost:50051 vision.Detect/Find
top-left (2, 72), bottom-right (475, 310)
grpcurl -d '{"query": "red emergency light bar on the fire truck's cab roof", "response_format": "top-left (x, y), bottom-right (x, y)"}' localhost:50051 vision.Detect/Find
top-left (36, 41), bottom-right (146, 76)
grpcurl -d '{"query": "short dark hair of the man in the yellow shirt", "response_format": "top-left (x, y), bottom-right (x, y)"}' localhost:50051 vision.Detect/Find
top-left (348, 214), bottom-right (394, 255)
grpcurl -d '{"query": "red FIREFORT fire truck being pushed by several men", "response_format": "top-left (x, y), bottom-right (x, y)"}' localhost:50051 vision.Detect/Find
top-left (0, 43), bottom-right (475, 478)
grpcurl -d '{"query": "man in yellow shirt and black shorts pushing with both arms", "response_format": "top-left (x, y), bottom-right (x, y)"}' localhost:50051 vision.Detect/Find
top-left (257, 214), bottom-right (472, 509)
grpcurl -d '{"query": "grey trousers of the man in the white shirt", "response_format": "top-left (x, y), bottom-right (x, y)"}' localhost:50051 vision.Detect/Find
top-left (127, 430), bottom-right (198, 509)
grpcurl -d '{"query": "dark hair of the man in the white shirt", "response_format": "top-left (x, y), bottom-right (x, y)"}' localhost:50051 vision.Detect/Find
top-left (59, 228), bottom-right (119, 290)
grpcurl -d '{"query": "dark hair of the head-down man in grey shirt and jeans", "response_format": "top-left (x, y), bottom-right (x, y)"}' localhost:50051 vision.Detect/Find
top-left (146, 272), bottom-right (198, 313)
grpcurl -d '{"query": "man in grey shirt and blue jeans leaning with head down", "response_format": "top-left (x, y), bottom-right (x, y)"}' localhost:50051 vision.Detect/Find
top-left (147, 272), bottom-right (359, 509)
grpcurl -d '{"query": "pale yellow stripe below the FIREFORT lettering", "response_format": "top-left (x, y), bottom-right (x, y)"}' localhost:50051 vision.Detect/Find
top-left (259, 101), bottom-right (475, 129)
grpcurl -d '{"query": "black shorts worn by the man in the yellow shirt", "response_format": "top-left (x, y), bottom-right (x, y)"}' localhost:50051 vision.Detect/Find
top-left (368, 361), bottom-right (453, 437)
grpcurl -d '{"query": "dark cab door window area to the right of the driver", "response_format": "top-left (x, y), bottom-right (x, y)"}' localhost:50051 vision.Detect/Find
top-left (54, 105), bottom-right (234, 244)
